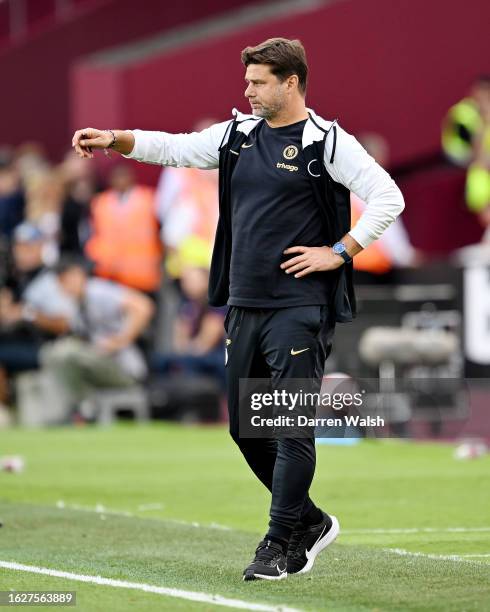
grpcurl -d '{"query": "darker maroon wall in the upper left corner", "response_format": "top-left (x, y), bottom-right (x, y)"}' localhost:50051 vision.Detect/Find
top-left (0, 0), bottom-right (260, 157)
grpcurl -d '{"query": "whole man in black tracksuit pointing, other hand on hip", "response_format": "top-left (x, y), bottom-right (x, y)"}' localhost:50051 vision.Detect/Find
top-left (73, 38), bottom-right (404, 580)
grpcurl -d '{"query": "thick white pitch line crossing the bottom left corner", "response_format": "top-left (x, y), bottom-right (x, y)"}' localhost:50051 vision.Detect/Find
top-left (0, 561), bottom-right (300, 612)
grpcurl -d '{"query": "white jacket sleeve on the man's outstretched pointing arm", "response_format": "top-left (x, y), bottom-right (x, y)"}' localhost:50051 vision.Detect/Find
top-left (124, 121), bottom-right (231, 170)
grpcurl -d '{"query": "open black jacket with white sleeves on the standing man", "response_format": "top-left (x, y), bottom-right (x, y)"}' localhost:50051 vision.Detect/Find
top-left (127, 109), bottom-right (405, 322)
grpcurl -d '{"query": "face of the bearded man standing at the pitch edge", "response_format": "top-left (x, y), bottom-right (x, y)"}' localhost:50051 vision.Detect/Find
top-left (245, 64), bottom-right (287, 119)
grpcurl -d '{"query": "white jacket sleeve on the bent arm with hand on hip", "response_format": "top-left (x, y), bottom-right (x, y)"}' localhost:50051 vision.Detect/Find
top-left (324, 125), bottom-right (405, 248)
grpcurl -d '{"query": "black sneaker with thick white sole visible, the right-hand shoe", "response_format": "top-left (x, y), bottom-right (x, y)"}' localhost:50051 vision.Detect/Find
top-left (287, 512), bottom-right (340, 574)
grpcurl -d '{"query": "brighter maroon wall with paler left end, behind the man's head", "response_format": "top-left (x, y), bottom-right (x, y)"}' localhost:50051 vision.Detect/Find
top-left (72, 0), bottom-right (490, 256)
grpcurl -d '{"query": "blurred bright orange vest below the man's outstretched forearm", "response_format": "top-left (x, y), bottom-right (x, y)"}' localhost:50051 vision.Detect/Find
top-left (85, 186), bottom-right (162, 291)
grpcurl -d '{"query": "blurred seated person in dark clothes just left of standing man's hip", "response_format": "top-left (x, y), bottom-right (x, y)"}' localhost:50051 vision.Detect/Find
top-left (152, 266), bottom-right (226, 384)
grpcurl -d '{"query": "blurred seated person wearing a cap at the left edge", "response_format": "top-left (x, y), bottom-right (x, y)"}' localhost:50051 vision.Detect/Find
top-left (0, 223), bottom-right (76, 403)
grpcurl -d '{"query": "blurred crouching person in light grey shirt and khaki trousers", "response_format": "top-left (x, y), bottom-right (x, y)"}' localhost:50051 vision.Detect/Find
top-left (41, 259), bottom-right (153, 418)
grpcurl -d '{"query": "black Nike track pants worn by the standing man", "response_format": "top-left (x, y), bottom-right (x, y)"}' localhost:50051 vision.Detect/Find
top-left (225, 306), bottom-right (333, 539)
